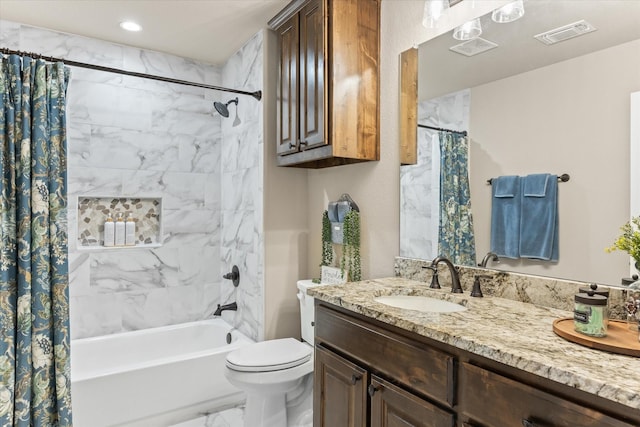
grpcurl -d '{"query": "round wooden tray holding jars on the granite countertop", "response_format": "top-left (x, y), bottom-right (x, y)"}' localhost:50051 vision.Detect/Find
top-left (553, 317), bottom-right (640, 357)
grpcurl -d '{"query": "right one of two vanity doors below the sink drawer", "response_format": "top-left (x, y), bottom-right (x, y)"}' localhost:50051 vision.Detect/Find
top-left (368, 375), bottom-right (454, 427)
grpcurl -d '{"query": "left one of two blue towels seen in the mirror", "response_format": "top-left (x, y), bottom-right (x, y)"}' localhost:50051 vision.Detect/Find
top-left (491, 176), bottom-right (522, 258)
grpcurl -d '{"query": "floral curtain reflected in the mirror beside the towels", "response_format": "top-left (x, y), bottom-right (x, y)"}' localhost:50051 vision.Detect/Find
top-left (438, 132), bottom-right (476, 265)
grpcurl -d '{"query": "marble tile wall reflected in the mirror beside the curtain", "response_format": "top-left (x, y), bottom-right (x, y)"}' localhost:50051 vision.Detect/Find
top-left (400, 90), bottom-right (470, 259)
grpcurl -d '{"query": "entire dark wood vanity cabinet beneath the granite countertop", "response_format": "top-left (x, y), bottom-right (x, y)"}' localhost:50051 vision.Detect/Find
top-left (314, 299), bottom-right (640, 427)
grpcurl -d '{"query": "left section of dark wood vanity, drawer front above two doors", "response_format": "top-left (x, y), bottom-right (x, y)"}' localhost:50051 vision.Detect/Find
top-left (314, 306), bottom-right (455, 427)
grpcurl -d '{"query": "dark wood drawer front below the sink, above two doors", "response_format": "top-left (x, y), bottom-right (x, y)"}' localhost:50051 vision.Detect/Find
top-left (315, 304), bottom-right (456, 407)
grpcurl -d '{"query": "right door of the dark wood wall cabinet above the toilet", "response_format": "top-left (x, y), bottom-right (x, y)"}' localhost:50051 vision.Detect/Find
top-left (299, 0), bottom-right (326, 150)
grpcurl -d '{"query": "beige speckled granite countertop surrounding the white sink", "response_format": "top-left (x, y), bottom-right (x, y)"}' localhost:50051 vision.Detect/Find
top-left (307, 277), bottom-right (640, 409)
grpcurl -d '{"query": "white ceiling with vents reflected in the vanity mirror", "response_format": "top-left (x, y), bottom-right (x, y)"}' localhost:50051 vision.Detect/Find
top-left (418, 0), bottom-right (640, 100)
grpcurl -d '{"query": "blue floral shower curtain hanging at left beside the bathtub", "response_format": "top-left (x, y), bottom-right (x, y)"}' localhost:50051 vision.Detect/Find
top-left (0, 55), bottom-right (72, 427)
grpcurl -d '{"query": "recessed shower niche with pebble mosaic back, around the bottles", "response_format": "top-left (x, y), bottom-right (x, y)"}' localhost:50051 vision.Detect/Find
top-left (77, 196), bottom-right (162, 250)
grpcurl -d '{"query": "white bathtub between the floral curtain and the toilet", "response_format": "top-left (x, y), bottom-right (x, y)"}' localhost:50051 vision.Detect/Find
top-left (71, 319), bottom-right (253, 427)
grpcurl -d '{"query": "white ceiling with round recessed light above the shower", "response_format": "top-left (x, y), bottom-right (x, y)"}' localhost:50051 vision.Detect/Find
top-left (0, 0), bottom-right (289, 65)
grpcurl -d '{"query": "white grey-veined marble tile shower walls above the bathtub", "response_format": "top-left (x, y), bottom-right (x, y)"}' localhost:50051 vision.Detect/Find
top-left (0, 21), bottom-right (262, 338)
